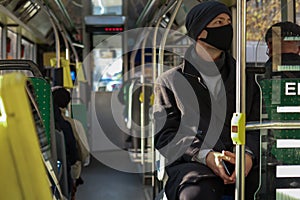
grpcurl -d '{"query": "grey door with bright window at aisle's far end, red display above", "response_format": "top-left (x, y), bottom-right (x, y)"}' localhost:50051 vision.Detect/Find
top-left (86, 16), bottom-right (126, 151)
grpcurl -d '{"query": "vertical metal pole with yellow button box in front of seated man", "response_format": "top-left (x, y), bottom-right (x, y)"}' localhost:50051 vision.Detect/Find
top-left (232, 0), bottom-right (246, 200)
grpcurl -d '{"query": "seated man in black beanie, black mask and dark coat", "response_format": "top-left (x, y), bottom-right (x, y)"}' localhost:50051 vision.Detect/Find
top-left (154, 1), bottom-right (259, 200)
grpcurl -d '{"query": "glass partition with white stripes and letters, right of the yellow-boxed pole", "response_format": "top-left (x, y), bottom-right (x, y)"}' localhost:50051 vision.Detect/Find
top-left (247, 1), bottom-right (300, 200)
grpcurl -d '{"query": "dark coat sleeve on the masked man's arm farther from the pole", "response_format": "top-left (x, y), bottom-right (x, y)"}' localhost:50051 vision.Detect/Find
top-left (153, 78), bottom-right (201, 162)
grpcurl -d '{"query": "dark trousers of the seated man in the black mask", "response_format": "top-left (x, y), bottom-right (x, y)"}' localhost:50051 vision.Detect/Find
top-left (165, 163), bottom-right (259, 200)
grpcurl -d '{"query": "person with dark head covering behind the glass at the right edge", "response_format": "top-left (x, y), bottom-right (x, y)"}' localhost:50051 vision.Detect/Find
top-left (265, 21), bottom-right (300, 78)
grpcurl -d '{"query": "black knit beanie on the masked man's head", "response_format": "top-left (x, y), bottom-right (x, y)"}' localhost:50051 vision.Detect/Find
top-left (185, 1), bottom-right (231, 40)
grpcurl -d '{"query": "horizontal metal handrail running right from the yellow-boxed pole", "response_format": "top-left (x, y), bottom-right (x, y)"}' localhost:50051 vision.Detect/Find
top-left (246, 121), bottom-right (300, 131)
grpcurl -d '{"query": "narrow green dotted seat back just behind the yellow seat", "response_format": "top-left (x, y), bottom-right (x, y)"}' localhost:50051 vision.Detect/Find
top-left (30, 77), bottom-right (52, 143)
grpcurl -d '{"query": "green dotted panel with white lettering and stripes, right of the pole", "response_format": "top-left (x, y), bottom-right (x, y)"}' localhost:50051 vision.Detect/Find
top-left (260, 79), bottom-right (300, 164)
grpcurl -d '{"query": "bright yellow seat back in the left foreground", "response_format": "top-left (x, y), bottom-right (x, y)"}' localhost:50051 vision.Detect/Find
top-left (0, 73), bottom-right (52, 200)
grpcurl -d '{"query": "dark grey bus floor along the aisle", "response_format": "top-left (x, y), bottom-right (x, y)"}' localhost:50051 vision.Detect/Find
top-left (75, 151), bottom-right (150, 200)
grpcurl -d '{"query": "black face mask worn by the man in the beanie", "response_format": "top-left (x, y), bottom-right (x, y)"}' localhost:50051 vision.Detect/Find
top-left (200, 24), bottom-right (233, 51)
